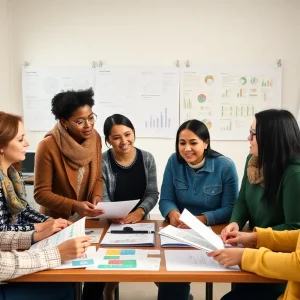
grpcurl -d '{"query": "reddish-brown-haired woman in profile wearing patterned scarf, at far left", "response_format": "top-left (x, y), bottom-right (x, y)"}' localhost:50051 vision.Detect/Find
top-left (0, 112), bottom-right (69, 231)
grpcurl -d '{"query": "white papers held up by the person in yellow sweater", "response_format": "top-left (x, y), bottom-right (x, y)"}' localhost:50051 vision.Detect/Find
top-left (159, 209), bottom-right (225, 252)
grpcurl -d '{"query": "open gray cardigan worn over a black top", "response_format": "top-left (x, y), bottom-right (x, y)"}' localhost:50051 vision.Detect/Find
top-left (102, 150), bottom-right (159, 216)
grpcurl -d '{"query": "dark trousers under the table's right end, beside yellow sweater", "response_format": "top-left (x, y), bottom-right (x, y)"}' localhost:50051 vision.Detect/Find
top-left (221, 283), bottom-right (285, 300)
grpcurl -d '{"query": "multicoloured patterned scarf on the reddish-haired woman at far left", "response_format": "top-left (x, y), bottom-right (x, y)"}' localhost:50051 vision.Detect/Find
top-left (0, 166), bottom-right (27, 221)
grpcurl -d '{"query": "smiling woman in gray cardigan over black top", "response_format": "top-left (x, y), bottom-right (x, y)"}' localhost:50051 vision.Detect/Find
top-left (85, 114), bottom-right (158, 300)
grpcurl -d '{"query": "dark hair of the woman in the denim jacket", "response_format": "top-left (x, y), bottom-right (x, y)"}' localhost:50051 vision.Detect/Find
top-left (175, 119), bottom-right (222, 163)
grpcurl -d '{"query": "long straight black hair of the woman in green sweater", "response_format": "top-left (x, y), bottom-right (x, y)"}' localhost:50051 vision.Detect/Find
top-left (255, 109), bottom-right (300, 204)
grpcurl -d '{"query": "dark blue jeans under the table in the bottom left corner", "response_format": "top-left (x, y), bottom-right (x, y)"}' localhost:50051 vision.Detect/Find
top-left (0, 282), bottom-right (74, 300)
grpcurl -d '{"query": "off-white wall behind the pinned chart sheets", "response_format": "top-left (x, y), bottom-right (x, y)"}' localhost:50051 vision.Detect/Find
top-left (0, 0), bottom-right (300, 216)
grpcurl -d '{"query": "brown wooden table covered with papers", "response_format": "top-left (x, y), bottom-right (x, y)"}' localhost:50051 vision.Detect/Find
top-left (11, 220), bottom-right (283, 300)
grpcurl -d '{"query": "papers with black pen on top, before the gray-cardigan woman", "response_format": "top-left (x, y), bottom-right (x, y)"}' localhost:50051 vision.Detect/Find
top-left (100, 223), bottom-right (155, 247)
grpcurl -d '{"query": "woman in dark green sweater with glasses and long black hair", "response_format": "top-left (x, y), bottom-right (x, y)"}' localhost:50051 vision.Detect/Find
top-left (221, 109), bottom-right (300, 300)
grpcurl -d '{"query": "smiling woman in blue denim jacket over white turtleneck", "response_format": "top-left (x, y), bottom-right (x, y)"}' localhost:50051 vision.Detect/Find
top-left (158, 120), bottom-right (238, 300)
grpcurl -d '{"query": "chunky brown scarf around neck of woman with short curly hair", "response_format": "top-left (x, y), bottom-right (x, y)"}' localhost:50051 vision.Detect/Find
top-left (45, 122), bottom-right (97, 170)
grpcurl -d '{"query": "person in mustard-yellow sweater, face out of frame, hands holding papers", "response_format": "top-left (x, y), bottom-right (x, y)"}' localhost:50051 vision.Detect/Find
top-left (208, 227), bottom-right (300, 300)
